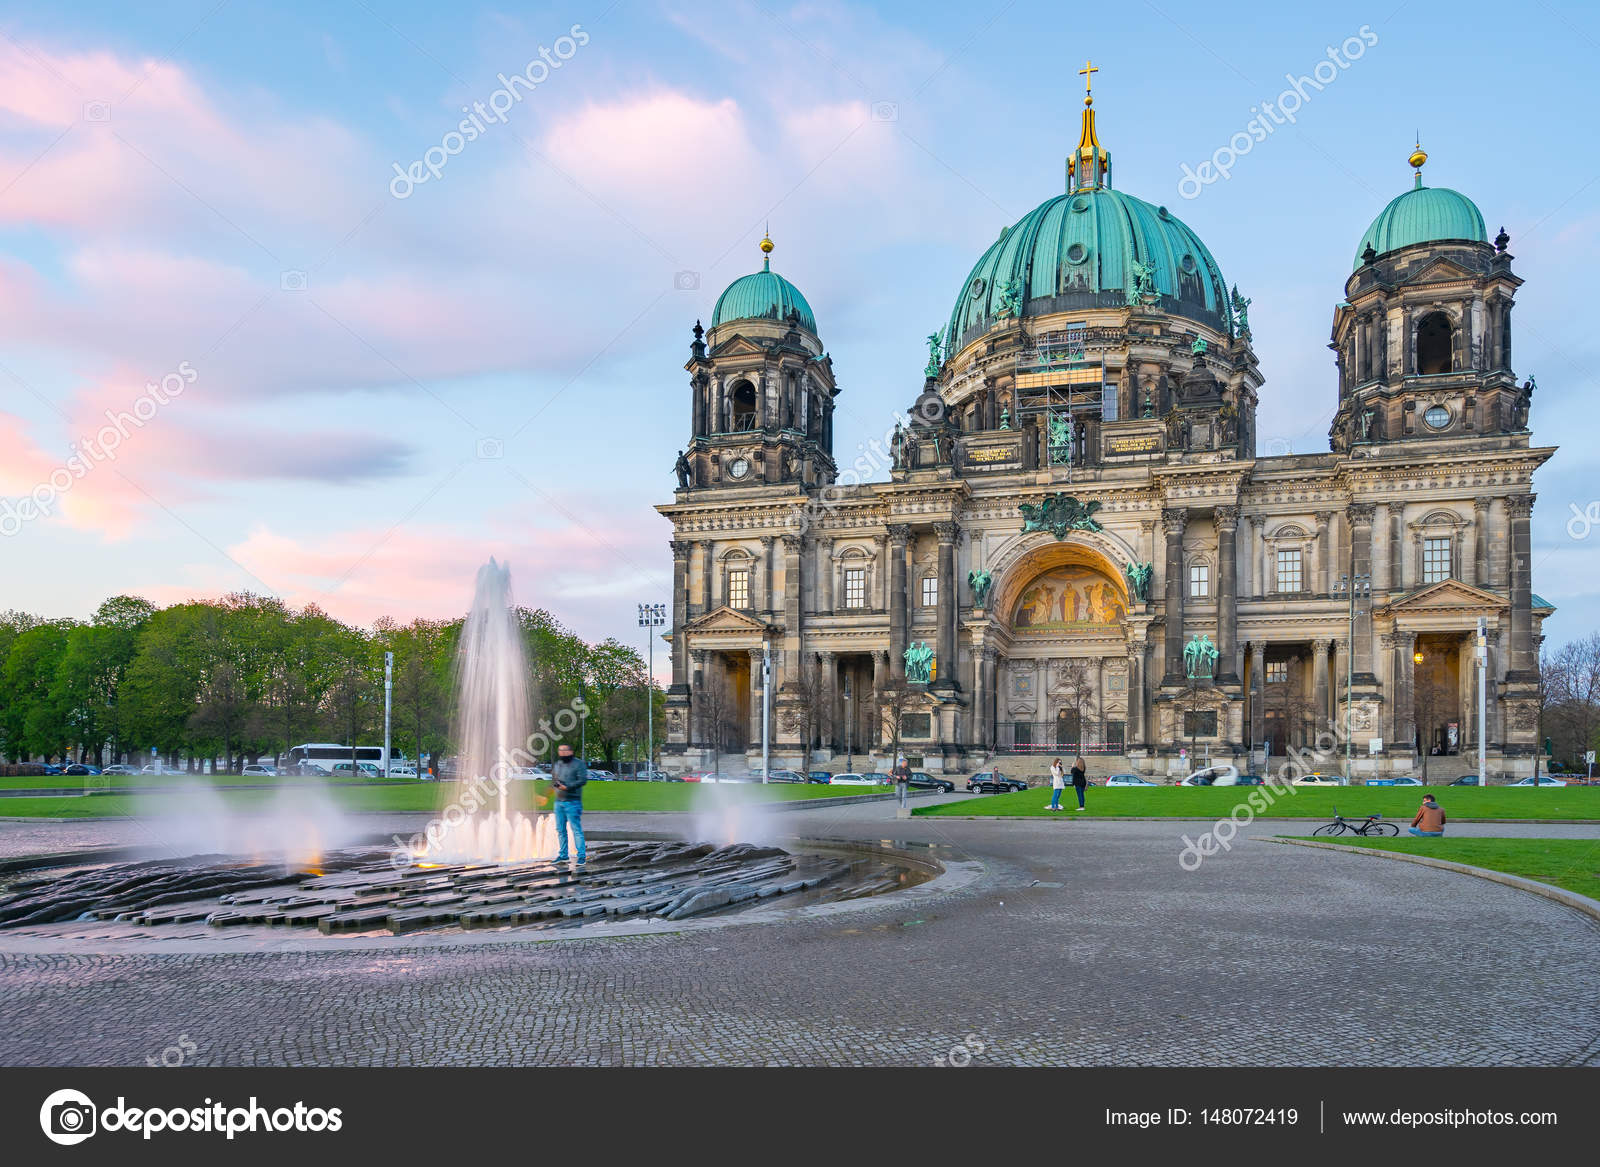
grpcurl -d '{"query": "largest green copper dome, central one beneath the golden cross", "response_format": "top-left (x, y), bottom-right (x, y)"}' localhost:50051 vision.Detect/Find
top-left (947, 186), bottom-right (1229, 351)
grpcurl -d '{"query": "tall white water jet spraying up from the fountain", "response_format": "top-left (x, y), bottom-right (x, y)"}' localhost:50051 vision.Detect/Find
top-left (427, 559), bottom-right (557, 863)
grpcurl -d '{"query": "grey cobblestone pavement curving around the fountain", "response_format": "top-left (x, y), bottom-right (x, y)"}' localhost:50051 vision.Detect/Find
top-left (0, 804), bottom-right (1600, 1066)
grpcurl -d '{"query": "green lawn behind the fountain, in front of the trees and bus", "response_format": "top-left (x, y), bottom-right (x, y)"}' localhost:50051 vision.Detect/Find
top-left (0, 783), bottom-right (882, 818)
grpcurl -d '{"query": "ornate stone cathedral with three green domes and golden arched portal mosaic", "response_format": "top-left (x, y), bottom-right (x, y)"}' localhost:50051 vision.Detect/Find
top-left (658, 72), bottom-right (1554, 781)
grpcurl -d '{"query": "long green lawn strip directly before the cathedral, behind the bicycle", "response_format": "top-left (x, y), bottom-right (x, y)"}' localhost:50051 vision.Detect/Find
top-left (912, 786), bottom-right (1600, 821)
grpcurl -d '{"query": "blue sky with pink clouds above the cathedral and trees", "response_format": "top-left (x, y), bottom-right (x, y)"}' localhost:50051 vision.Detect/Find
top-left (0, 0), bottom-right (1600, 664)
